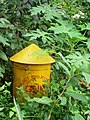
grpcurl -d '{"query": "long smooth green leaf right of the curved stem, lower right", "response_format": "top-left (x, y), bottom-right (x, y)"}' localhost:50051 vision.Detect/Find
top-left (66, 92), bottom-right (87, 102)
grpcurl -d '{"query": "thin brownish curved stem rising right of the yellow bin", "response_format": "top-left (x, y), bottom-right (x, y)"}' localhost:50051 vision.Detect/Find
top-left (48, 78), bottom-right (71, 120)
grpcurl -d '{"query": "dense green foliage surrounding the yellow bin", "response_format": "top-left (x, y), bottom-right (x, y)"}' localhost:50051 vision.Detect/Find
top-left (0, 0), bottom-right (90, 120)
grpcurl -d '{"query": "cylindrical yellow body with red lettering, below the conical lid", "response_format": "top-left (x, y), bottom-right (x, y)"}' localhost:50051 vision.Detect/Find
top-left (13, 63), bottom-right (51, 97)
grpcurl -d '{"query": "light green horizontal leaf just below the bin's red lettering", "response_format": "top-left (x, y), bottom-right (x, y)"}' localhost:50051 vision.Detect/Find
top-left (31, 96), bottom-right (53, 105)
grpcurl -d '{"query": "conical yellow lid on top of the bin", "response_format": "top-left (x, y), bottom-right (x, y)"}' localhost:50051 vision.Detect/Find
top-left (10, 44), bottom-right (55, 64)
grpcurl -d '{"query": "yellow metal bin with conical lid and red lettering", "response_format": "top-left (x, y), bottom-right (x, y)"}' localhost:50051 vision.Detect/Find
top-left (10, 44), bottom-right (55, 97)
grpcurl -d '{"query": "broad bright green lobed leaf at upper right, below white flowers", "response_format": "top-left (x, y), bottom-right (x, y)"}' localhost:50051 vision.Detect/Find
top-left (49, 21), bottom-right (87, 40)
